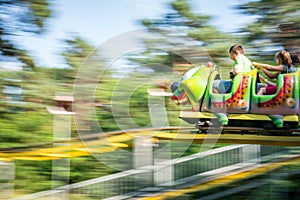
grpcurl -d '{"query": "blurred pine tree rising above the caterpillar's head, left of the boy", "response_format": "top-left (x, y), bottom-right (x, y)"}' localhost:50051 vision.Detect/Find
top-left (135, 0), bottom-right (231, 74)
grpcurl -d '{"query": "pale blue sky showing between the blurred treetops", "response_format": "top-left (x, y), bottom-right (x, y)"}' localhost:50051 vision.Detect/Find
top-left (20, 0), bottom-right (251, 67)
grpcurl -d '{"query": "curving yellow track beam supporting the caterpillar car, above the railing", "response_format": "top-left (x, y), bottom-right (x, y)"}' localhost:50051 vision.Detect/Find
top-left (0, 130), bottom-right (300, 161)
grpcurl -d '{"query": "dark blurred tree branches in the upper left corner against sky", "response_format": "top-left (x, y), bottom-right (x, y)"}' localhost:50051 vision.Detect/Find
top-left (0, 0), bottom-right (51, 68)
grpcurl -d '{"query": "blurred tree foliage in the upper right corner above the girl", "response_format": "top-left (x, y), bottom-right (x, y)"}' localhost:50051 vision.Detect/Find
top-left (236, 0), bottom-right (300, 60)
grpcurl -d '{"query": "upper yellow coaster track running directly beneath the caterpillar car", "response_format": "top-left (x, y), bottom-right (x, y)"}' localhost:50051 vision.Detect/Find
top-left (0, 126), bottom-right (300, 161)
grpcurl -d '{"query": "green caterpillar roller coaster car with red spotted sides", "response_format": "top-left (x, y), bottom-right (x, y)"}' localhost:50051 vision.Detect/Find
top-left (171, 65), bottom-right (300, 133)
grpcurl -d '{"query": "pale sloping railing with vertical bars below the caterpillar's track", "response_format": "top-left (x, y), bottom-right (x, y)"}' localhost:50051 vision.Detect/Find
top-left (13, 145), bottom-right (283, 199)
